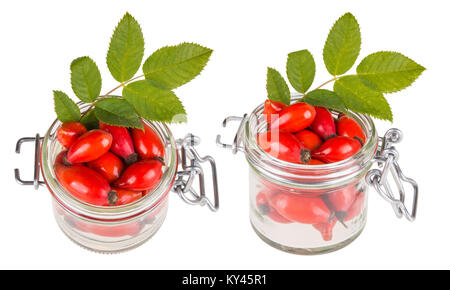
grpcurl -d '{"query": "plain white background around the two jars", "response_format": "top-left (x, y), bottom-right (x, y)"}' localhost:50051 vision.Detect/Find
top-left (0, 0), bottom-right (450, 269)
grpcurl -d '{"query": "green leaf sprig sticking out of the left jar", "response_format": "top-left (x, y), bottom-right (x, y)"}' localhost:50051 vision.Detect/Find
top-left (53, 13), bottom-right (212, 128)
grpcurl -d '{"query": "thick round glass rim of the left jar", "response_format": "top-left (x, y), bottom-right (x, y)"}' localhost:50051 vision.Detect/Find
top-left (40, 102), bottom-right (178, 220)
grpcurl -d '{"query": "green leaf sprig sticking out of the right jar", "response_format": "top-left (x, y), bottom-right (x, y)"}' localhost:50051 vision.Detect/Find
top-left (266, 13), bottom-right (425, 122)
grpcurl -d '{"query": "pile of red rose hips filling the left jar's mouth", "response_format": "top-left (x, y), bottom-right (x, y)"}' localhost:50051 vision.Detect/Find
top-left (54, 122), bottom-right (164, 206)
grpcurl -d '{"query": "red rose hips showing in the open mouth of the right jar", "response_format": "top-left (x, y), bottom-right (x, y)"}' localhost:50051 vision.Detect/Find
top-left (258, 100), bottom-right (366, 165)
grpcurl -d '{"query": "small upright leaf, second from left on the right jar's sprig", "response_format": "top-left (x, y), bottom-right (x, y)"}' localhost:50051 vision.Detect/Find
top-left (286, 50), bottom-right (316, 94)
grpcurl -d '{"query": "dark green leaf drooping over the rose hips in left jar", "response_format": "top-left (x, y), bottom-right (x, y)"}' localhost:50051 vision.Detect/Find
top-left (95, 98), bottom-right (143, 129)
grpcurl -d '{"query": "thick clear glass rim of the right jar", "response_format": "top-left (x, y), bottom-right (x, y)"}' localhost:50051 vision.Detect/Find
top-left (243, 95), bottom-right (379, 187)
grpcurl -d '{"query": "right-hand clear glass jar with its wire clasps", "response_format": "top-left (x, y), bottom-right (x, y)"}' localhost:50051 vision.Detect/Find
top-left (217, 98), bottom-right (418, 255)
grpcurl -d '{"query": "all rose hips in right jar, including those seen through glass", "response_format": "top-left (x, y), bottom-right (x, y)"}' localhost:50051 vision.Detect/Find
top-left (256, 100), bottom-right (366, 241)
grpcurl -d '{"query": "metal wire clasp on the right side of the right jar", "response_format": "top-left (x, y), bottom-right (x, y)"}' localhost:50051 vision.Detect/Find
top-left (366, 128), bottom-right (419, 221)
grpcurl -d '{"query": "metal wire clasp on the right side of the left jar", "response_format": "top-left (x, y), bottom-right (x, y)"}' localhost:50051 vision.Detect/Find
top-left (173, 134), bottom-right (219, 212)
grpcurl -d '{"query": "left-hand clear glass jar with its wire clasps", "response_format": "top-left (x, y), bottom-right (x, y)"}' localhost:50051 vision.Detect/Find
top-left (15, 103), bottom-right (219, 252)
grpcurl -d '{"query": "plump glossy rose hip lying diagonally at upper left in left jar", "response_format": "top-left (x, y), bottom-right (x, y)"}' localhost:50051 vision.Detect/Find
top-left (67, 129), bottom-right (112, 164)
